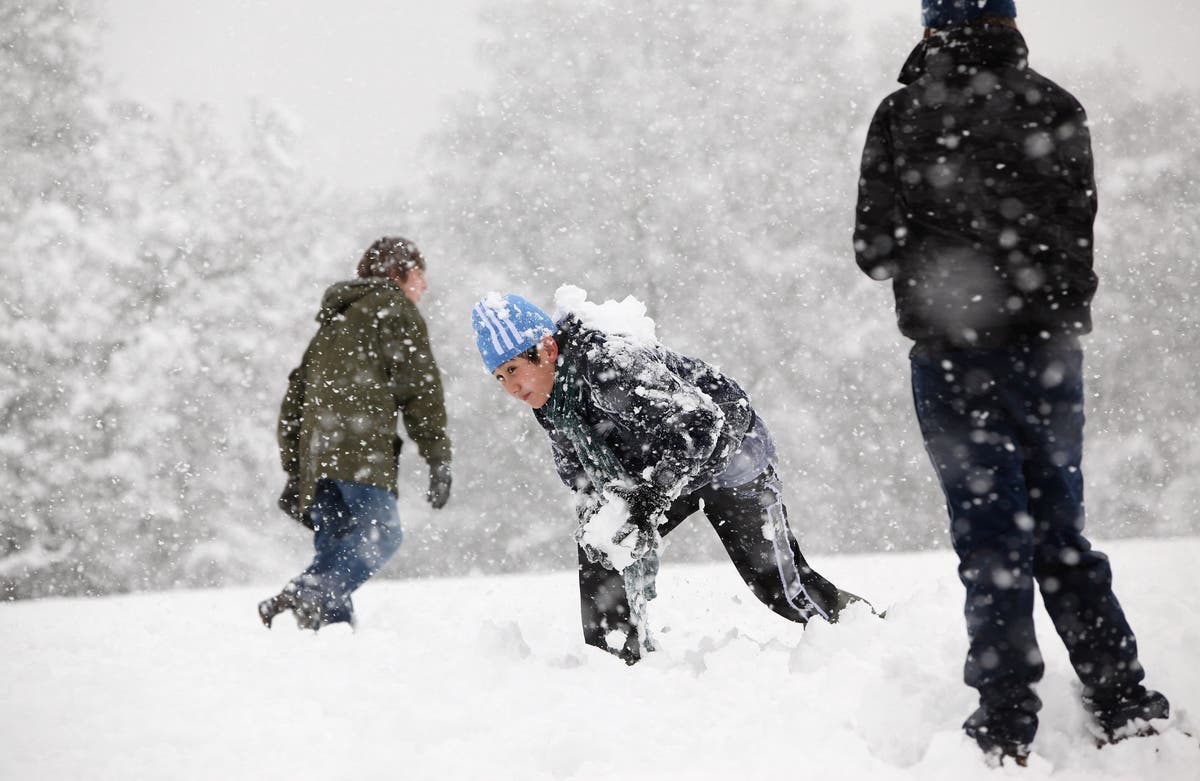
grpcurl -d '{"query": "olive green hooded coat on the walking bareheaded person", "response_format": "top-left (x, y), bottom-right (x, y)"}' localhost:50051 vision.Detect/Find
top-left (278, 278), bottom-right (450, 510)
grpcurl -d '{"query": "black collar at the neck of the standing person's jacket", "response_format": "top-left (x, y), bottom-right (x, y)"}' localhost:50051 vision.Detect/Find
top-left (898, 25), bottom-right (1030, 84)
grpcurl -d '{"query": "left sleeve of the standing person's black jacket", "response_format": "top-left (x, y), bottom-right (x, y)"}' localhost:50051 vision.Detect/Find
top-left (854, 98), bottom-right (904, 280)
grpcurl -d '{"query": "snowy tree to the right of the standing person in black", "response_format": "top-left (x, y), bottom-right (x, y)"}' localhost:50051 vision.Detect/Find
top-left (1085, 82), bottom-right (1200, 535)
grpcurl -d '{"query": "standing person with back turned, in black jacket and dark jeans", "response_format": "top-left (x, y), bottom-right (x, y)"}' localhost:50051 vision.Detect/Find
top-left (854, 0), bottom-right (1169, 764)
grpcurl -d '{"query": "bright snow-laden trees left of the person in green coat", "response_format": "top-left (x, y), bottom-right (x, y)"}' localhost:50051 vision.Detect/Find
top-left (0, 0), bottom-right (345, 595)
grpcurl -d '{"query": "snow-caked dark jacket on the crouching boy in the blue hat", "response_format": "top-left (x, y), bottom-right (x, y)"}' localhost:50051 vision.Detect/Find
top-left (534, 316), bottom-right (754, 509)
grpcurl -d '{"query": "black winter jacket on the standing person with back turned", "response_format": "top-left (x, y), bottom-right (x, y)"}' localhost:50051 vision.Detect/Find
top-left (854, 25), bottom-right (1096, 348)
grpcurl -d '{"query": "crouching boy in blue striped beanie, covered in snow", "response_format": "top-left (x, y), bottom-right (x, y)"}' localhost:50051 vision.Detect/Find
top-left (472, 287), bottom-right (858, 665)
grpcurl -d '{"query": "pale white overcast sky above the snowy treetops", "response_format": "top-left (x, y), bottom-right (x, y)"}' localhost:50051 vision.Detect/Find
top-left (103, 0), bottom-right (1200, 187)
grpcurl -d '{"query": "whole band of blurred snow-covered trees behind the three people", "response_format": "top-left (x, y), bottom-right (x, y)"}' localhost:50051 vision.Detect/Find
top-left (0, 0), bottom-right (1200, 597)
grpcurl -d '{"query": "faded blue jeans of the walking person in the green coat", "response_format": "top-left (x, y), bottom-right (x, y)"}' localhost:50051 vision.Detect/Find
top-left (292, 480), bottom-right (403, 624)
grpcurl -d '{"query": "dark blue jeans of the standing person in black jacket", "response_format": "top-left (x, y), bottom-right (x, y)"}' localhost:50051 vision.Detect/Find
top-left (912, 346), bottom-right (1144, 739)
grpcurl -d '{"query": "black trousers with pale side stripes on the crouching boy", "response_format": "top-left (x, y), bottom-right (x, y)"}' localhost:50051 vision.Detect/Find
top-left (580, 467), bottom-right (839, 661)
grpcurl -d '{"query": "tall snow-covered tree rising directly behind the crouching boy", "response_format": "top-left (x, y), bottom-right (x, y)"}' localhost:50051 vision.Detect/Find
top-left (417, 0), bottom-right (931, 566)
